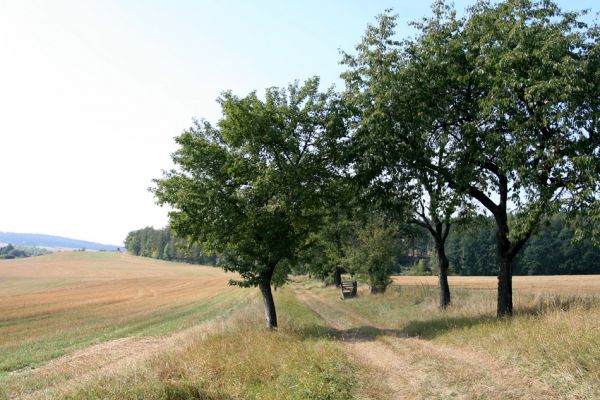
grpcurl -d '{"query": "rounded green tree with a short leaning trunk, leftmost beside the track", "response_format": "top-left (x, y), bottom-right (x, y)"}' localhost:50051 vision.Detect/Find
top-left (153, 78), bottom-right (345, 328)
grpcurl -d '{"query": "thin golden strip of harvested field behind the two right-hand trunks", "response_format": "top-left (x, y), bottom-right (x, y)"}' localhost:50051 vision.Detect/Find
top-left (393, 275), bottom-right (600, 295)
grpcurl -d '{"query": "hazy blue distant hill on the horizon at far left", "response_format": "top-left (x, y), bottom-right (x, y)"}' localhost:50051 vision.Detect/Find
top-left (0, 232), bottom-right (119, 251)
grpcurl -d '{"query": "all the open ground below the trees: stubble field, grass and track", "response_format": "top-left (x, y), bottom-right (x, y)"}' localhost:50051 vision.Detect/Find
top-left (0, 252), bottom-right (600, 399)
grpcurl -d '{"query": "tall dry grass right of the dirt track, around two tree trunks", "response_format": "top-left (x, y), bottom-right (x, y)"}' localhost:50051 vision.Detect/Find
top-left (322, 286), bottom-right (600, 399)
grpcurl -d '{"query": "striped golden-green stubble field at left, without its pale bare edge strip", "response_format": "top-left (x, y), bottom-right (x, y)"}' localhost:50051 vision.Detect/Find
top-left (0, 252), bottom-right (251, 396)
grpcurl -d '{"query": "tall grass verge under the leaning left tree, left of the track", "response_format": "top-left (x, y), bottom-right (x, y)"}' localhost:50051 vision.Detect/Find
top-left (65, 290), bottom-right (356, 400)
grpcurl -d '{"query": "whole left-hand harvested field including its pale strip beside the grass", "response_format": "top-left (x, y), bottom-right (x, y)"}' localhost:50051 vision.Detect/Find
top-left (0, 252), bottom-right (250, 399)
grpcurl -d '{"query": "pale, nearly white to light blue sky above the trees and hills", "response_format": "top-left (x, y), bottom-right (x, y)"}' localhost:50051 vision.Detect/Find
top-left (0, 0), bottom-right (600, 245)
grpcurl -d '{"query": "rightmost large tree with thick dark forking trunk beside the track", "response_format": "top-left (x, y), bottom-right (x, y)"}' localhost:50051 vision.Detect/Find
top-left (450, 0), bottom-right (599, 317)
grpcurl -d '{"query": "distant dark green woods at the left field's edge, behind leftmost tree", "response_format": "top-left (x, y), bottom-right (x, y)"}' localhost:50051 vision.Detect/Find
top-left (125, 227), bottom-right (216, 265)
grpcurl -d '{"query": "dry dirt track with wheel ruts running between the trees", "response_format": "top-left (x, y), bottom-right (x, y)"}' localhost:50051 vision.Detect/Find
top-left (295, 287), bottom-right (559, 399)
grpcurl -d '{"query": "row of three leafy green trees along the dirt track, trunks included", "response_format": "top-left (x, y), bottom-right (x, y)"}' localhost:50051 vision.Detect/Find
top-left (152, 0), bottom-right (600, 327)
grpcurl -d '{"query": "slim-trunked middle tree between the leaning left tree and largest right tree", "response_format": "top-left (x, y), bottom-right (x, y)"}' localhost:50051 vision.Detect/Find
top-left (343, 7), bottom-right (461, 308)
